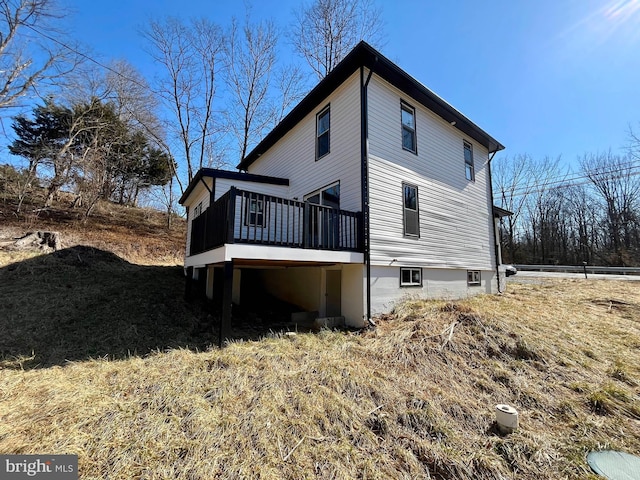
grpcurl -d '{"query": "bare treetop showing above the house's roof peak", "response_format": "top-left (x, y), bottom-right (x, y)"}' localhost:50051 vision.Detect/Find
top-left (290, 0), bottom-right (384, 79)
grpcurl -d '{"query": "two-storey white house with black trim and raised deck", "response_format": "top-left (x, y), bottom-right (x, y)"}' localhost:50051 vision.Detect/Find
top-left (180, 42), bottom-right (509, 342)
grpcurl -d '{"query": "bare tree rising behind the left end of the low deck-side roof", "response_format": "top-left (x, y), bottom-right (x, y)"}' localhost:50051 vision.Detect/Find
top-left (144, 18), bottom-right (223, 182)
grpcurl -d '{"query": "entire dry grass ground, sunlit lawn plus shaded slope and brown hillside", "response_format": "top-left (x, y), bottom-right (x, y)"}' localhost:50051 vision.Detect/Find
top-left (0, 190), bottom-right (640, 480)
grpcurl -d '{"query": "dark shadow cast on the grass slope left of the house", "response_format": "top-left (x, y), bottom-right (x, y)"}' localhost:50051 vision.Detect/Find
top-left (0, 246), bottom-right (217, 369)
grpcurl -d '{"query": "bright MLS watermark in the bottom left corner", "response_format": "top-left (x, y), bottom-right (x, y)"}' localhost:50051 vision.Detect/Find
top-left (0, 455), bottom-right (78, 480)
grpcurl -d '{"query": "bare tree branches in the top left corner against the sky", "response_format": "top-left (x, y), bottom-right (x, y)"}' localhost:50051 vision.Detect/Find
top-left (0, 0), bottom-right (79, 108)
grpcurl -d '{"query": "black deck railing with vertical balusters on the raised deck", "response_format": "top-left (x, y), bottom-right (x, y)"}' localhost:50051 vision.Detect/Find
top-left (189, 187), bottom-right (362, 255)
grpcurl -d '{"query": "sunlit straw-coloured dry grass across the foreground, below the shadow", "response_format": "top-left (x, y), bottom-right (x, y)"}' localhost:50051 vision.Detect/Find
top-left (0, 272), bottom-right (640, 479)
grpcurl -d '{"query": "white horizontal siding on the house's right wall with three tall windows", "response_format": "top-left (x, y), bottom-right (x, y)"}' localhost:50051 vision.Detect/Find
top-left (369, 75), bottom-right (495, 272)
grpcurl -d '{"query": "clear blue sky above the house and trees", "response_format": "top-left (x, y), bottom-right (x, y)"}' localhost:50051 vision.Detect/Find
top-left (56, 0), bottom-right (640, 163)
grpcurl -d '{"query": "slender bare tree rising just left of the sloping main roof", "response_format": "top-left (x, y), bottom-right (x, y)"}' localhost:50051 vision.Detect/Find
top-left (225, 12), bottom-right (278, 160)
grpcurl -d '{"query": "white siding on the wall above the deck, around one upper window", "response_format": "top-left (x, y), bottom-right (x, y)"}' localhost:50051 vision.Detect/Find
top-left (249, 72), bottom-right (362, 211)
